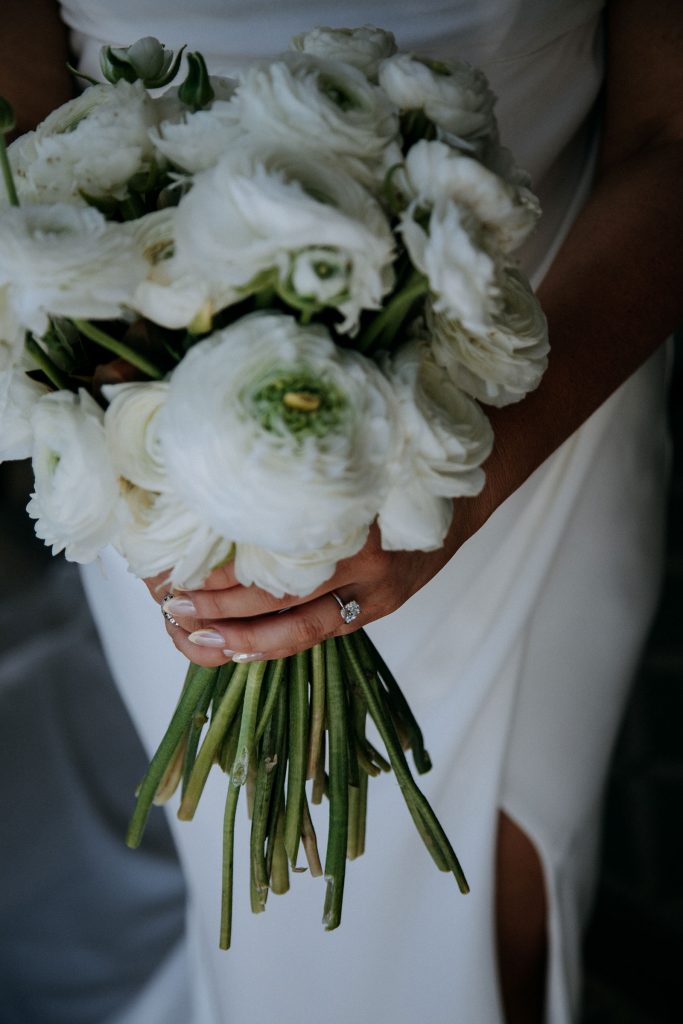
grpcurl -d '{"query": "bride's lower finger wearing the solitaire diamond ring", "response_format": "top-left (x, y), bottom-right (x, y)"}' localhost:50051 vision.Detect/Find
top-left (169, 592), bottom-right (373, 666)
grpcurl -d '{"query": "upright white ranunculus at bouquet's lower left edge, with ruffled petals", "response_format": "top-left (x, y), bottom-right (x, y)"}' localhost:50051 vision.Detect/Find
top-left (27, 390), bottom-right (122, 562)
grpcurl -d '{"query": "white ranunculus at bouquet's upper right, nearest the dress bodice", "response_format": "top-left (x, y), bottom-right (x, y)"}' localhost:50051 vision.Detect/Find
top-left (379, 53), bottom-right (497, 146)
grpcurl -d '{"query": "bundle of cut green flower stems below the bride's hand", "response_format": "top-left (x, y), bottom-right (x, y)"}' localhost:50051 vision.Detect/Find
top-left (127, 630), bottom-right (468, 949)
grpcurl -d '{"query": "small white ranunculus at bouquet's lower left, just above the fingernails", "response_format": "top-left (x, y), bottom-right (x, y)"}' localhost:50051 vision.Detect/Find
top-left (116, 486), bottom-right (232, 589)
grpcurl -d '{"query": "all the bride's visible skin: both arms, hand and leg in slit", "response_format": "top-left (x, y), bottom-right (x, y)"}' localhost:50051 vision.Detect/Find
top-left (0, 0), bottom-right (683, 1024)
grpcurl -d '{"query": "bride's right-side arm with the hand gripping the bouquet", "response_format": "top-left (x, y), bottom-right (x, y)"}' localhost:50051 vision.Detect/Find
top-left (157, 0), bottom-right (683, 665)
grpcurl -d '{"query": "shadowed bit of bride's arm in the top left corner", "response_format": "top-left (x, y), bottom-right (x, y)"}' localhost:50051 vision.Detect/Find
top-left (0, 0), bottom-right (75, 135)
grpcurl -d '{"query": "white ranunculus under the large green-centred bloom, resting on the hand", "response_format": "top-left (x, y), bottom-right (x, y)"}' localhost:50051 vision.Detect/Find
top-left (234, 526), bottom-right (368, 597)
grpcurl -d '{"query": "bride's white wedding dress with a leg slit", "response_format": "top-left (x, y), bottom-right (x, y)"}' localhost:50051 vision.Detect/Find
top-left (62, 0), bottom-right (666, 1024)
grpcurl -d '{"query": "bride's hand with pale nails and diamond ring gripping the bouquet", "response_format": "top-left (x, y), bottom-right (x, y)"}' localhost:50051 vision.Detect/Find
top-left (145, 526), bottom-right (475, 667)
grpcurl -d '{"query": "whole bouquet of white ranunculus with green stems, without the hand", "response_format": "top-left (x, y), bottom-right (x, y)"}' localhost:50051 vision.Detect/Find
top-left (0, 27), bottom-right (548, 947)
